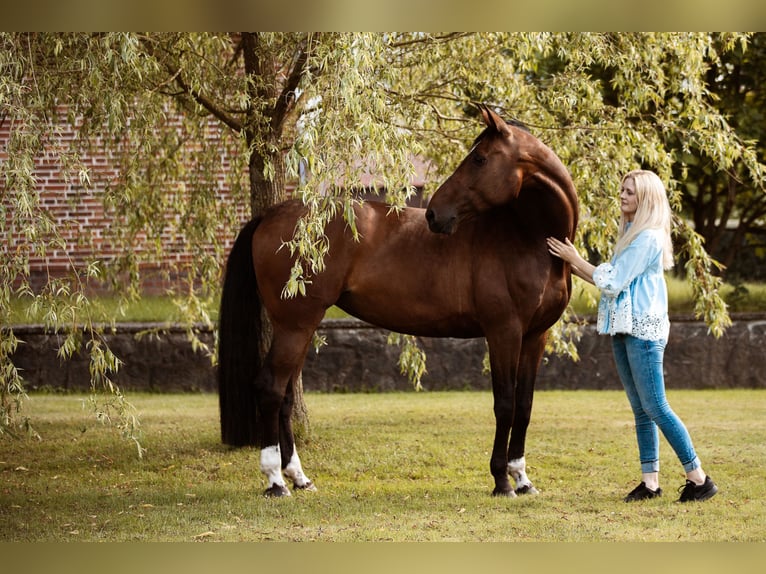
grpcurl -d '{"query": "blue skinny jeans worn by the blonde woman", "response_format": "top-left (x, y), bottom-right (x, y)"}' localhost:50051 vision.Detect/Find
top-left (612, 335), bottom-right (700, 473)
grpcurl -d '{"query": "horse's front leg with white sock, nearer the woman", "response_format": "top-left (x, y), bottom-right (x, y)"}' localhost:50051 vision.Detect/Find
top-left (508, 333), bottom-right (545, 494)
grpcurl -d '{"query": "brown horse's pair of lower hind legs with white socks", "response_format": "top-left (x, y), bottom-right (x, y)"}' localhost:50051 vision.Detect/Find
top-left (256, 327), bottom-right (313, 496)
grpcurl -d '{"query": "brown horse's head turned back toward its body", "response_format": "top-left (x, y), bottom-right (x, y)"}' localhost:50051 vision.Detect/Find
top-left (426, 106), bottom-right (537, 234)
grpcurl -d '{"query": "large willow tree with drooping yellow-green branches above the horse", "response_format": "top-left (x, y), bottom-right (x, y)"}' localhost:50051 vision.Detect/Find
top-left (0, 33), bottom-right (764, 450)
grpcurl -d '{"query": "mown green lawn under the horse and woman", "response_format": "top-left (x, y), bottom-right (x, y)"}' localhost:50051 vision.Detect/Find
top-left (0, 390), bottom-right (766, 542)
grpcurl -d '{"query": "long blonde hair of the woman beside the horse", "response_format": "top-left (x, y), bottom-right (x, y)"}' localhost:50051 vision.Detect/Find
top-left (614, 169), bottom-right (673, 269)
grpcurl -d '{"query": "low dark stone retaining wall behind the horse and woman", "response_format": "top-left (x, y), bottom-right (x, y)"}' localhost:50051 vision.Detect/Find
top-left (7, 315), bottom-right (766, 392)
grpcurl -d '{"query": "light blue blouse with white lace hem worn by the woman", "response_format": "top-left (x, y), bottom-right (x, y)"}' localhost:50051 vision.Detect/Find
top-left (593, 229), bottom-right (670, 341)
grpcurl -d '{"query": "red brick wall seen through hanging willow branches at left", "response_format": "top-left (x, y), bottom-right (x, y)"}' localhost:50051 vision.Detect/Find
top-left (0, 107), bottom-right (249, 293)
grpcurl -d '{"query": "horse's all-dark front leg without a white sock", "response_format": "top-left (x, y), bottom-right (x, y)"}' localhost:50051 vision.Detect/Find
top-left (487, 333), bottom-right (520, 497)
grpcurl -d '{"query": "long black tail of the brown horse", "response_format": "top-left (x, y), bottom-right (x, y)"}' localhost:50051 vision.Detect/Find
top-left (218, 219), bottom-right (263, 446)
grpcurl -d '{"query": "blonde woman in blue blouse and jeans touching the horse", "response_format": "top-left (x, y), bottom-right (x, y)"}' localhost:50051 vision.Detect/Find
top-left (548, 170), bottom-right (718, 502)
